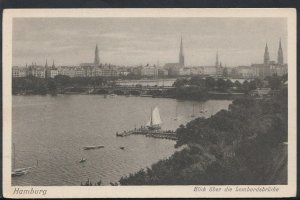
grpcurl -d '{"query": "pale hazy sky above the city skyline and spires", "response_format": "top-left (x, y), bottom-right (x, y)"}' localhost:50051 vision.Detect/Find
top-left (12, 17), bottom-right (287, 66)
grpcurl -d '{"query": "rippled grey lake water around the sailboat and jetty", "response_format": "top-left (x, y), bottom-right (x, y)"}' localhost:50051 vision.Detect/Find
top-left (12, 95), bottom-right (231, 186)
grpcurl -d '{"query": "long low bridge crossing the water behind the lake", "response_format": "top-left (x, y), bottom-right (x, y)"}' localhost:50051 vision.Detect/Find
top-left (61, 85), bottom-right (174, 95)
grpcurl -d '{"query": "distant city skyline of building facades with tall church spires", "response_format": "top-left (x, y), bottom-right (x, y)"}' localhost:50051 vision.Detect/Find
top-left (12, 38), bottom-right (288, 78)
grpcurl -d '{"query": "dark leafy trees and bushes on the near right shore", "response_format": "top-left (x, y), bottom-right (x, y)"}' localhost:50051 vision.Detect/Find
top-left (119, 84), bottom-right (288, 185)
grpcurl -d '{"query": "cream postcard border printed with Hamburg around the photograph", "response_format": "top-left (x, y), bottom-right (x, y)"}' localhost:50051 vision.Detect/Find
top-left (2, 8), bottom-right (297, 198)
